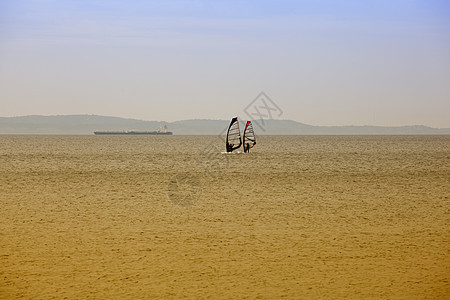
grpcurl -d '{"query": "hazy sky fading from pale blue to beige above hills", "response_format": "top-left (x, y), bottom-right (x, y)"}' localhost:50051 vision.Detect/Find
top-left (0, 0), bottom-right (450, 128)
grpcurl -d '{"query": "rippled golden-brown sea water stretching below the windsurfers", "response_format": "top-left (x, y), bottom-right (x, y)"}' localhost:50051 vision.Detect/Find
top-left (0, 136), bottom-right (450, 299)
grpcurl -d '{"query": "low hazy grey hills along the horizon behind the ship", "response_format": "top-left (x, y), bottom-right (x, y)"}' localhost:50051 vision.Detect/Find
top-left (0, 115), bottom-right (450, 135)
